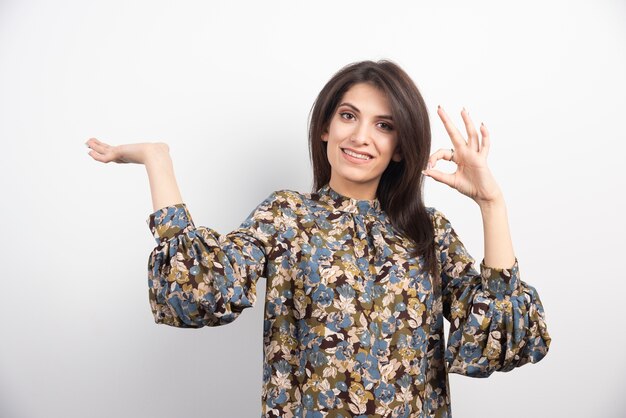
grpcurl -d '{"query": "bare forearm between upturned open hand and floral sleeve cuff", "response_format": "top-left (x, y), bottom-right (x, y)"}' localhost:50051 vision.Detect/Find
top-left (145, 147), bottom-right (183, 211)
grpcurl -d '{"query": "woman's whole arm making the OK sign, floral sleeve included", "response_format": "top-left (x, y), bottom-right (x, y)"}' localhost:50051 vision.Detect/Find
top-left (422, 107), bottom-right (551, 377)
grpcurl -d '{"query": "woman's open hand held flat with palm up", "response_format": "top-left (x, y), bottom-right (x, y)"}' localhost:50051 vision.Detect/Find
top-left (85, 138), bottom-right (169, 164)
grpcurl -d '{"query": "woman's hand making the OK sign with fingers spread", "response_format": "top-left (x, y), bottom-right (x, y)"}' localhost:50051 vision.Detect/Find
top-left (423, 107), bottom-right (502, 205)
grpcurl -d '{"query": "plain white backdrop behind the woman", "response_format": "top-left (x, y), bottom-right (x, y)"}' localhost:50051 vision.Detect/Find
top-left (0, 0), bottom-right (626, 418)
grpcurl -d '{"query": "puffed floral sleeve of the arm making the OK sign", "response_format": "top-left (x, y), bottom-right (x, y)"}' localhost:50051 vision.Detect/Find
top-left (432, 210), bottom-right (551, 377)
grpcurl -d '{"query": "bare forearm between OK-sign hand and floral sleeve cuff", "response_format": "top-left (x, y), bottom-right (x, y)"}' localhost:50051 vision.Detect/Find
top-left (479, 197), bottom-right (515, 268)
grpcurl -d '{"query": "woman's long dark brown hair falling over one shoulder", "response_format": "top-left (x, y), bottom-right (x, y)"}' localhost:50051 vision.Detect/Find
top-left (309, 60), bottom-right (437, 277)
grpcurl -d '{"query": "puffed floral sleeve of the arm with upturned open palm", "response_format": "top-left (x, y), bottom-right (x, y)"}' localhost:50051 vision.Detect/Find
top-left (146, 193), bottom-right (277, 328)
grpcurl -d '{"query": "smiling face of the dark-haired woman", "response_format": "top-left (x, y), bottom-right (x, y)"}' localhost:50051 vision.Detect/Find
top-left (322, 83), bottom-right (401, 200)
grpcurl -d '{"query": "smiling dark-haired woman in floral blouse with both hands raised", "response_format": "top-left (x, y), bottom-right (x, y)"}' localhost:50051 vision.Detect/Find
top-left (87, 61), bottom-right (551, 418)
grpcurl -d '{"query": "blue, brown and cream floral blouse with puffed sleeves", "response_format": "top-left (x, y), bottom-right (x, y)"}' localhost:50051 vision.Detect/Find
top-left (147, 184), bottom-right (551, 418)
